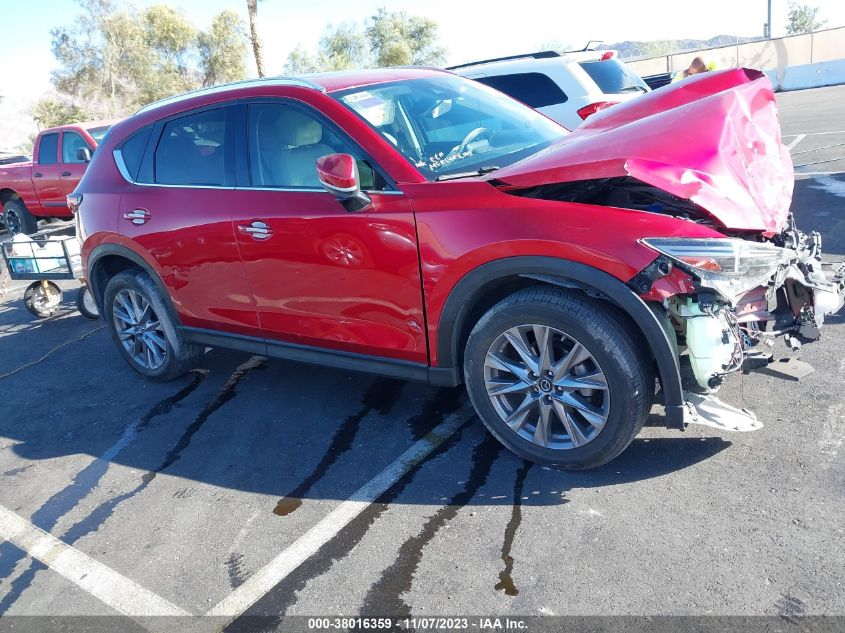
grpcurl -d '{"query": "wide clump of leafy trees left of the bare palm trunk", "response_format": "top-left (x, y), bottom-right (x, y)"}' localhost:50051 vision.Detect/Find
top-left (51, 0), bottom-right (246, 117)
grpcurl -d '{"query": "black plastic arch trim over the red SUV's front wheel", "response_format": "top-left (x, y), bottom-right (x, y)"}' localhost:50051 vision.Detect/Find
top-left (437, 256), bottom-right (684, 429)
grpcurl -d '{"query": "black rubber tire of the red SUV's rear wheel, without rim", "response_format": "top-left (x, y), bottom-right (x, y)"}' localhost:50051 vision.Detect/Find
top-left (103, 269), bottom-right (203, 382)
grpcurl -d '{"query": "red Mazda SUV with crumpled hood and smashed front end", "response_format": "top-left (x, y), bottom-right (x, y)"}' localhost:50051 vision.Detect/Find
top-left (74, 68), bottom-right (844, 469)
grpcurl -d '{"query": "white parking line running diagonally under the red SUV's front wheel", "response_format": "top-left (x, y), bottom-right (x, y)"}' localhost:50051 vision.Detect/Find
top-left (206, 415), bottom-right (463, 619)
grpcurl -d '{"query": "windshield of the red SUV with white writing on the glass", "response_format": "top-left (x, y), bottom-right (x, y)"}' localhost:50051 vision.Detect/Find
top-left (334, 74), bottom-right (568, 180)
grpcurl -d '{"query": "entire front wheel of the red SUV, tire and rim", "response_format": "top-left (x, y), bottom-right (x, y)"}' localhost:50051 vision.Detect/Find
top-left (464, 287), bottom-right (654, 470)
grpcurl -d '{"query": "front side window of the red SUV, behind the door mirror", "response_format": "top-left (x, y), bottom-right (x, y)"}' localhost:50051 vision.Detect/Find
top-left (247, 103), bottom-right (386, 190)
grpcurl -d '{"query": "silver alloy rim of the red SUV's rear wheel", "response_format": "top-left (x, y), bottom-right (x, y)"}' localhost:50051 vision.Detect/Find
top-left (112, 289), bottom-right (167, 370)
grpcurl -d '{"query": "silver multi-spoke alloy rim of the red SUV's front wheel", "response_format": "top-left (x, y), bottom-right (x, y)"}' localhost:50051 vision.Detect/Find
top-left (484, 324), bottom-right (610, 450)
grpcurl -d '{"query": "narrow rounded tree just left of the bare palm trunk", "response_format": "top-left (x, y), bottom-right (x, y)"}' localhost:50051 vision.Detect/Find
top-left (197, 10), bottom-right (246, 86)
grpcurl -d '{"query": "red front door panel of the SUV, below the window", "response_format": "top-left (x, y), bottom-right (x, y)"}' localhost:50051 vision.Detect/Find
top-left (235, 189), bottom-right (427, 363)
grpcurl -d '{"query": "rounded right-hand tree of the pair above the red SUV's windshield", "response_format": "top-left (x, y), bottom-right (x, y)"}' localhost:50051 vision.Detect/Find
top-left (366, 7), bottom-right (446, 66)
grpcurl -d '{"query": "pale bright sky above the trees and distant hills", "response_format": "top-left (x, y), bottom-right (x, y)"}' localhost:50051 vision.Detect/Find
top-left (0, 0), bottom-right (845, 106)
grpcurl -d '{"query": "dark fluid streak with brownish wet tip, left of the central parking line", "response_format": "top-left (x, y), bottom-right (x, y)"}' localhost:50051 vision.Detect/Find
top-left (273, 378), bottom-right (405, 516)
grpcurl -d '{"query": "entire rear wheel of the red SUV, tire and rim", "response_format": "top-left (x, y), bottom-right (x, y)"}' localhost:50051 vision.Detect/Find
top-left (103, 270), bottom-right (202, 381)
